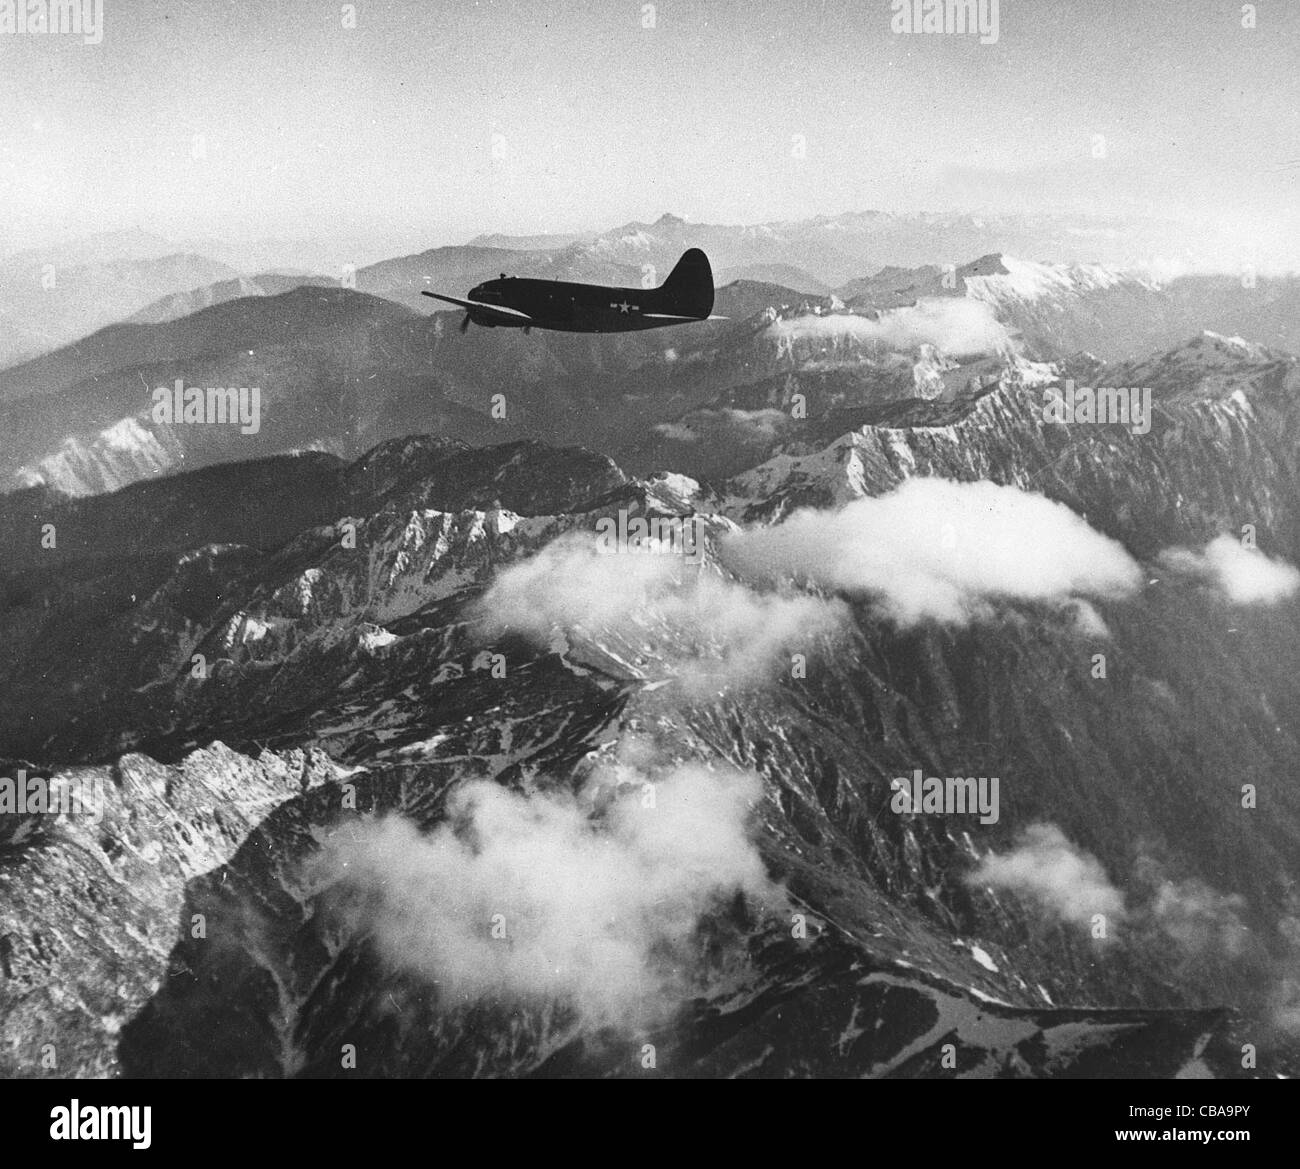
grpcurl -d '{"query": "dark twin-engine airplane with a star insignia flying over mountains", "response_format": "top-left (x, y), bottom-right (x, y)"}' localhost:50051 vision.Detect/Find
top-left (421, 247), bottom-right (727, 334)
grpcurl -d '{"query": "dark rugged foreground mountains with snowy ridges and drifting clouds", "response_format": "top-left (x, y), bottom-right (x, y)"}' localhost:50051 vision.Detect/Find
top-left (0, 332), bottom-right (1300, 1077)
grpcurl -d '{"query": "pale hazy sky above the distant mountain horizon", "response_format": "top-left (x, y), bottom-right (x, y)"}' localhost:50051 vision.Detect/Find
top-left (0, 0), bottom-right (1300, 254)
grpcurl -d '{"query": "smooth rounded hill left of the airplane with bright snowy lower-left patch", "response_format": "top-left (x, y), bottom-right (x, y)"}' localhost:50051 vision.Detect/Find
top-left (0, 286), bottom-right (512, 494)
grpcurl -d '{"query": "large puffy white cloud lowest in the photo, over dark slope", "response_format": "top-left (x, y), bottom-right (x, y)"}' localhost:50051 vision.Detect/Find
top-left (312, 761), bottom-right (784, 1026)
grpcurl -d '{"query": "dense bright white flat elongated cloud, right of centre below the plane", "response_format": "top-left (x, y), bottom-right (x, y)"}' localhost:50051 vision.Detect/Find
top-left (722, 479), bottom-right (1143, 633)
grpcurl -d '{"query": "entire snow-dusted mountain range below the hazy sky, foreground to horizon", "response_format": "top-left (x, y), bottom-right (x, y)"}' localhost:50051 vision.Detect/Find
top-left (0, 213), bottom-right (1300, 1079)
